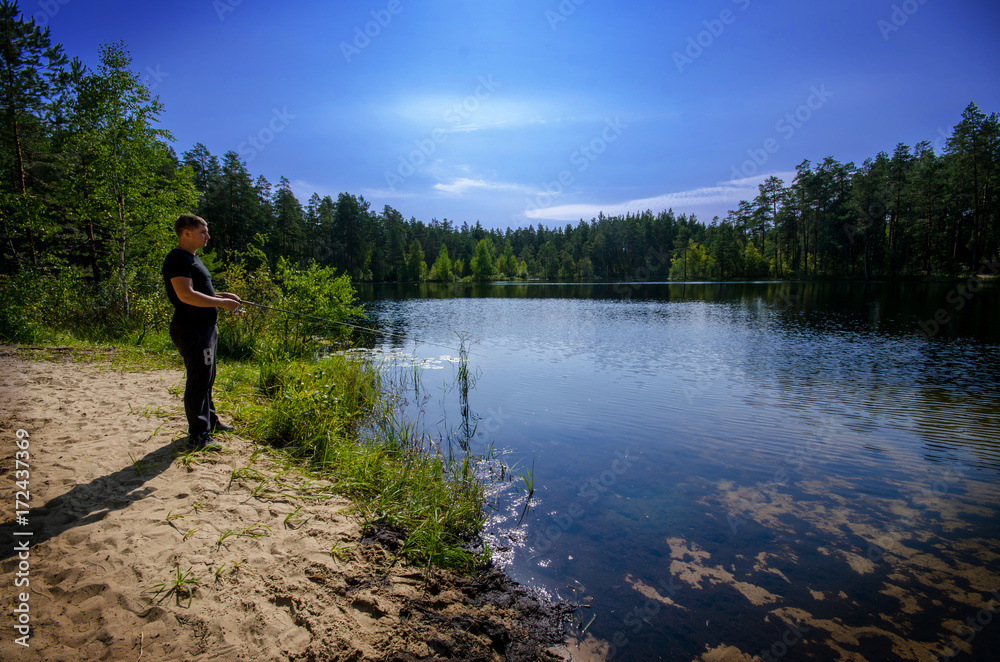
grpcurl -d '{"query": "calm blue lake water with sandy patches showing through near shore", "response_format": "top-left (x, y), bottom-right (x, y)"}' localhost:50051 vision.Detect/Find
top-left (361, 282), bottom-right (1000, 660)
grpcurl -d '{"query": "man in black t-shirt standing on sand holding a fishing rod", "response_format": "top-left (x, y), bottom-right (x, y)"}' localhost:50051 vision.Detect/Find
top-left (163, 214), bottom-right (242, 450)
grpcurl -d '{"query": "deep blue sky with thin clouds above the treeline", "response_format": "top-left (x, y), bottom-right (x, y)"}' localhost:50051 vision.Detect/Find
top-left (37, 0), bottom-right (1000, 228)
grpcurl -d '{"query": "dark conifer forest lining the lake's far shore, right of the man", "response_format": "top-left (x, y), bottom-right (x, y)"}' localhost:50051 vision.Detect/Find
top-left (168, 103), bottom-right (1000, 281)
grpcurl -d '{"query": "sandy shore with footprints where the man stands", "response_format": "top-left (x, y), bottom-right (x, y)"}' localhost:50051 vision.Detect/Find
top-left (0, 346), bottom-right (577, 662)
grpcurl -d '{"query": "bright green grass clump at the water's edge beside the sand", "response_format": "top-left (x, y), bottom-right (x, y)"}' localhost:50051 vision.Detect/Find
top-left (239, 355), bottom-right (484, 568)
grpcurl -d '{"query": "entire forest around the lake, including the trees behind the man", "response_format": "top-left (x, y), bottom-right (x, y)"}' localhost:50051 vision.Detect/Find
top-left (0, 0), bottom-right (1000, 344)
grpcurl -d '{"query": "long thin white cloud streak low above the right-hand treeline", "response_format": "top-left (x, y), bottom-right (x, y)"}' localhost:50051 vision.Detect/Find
top-left (524, 172), bottom-right (795, 221)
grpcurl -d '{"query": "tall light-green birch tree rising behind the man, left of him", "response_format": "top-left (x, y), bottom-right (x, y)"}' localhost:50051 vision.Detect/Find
top-left (61, 43), bottom-right (195, 322)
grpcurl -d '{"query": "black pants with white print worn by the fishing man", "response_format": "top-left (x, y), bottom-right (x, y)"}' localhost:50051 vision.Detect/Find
top-left (170, 324), bottom-right (219, 437)
